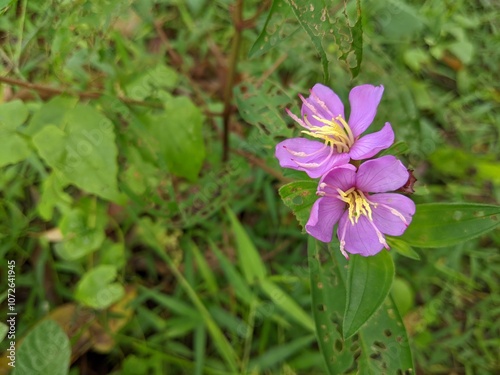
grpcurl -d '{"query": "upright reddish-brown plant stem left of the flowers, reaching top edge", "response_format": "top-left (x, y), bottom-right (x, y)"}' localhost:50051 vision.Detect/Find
top-left (222, 0), bottom-right (243, 162)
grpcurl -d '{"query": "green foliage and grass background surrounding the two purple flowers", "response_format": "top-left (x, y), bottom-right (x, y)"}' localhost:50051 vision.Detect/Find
top-left (0, 0), bottom-right (500, 375)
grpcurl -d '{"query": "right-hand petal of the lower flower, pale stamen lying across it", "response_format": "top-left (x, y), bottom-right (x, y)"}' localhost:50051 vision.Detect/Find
top-left (369, 193), bottom-right (415, 236)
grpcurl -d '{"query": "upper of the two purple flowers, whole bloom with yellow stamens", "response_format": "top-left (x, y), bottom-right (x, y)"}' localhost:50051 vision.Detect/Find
top-left (276, 83), bottom-right (394, 178)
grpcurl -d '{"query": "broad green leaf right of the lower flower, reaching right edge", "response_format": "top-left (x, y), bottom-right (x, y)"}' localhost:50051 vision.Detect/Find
top-left (401, 203), bottom-right (500, 247)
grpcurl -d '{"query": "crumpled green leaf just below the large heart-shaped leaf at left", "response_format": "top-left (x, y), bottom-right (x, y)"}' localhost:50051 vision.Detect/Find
top-left (56, 198), bottom-right (107, 260)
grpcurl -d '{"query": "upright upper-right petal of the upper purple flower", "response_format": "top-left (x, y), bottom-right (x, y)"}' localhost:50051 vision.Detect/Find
top-left (349, 85), bottom-right (384, 137)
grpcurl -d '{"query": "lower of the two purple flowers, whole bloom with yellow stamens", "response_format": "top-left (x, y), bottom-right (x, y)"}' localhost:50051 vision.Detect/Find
top-left (306, 155), bottom-right (415, 258)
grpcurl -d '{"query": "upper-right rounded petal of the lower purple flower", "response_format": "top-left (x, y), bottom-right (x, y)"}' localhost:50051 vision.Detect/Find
top-left (356, 155), bottom-right (409, 193)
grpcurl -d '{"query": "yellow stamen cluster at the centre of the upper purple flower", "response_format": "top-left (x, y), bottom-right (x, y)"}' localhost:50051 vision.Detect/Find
top-left (302, 115), bottom-right (354, 153)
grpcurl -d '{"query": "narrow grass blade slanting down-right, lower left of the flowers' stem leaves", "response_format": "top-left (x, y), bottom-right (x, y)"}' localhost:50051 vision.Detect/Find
top-left (260, 279), bottom-right (314, 332)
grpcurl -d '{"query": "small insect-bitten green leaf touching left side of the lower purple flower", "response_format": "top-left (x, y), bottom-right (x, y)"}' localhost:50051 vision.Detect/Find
top-left (279, 180), bottom-right (318, 228)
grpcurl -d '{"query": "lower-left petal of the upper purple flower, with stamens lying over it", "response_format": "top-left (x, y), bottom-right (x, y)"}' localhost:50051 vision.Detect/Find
top-left (275, 138), bottom-right (350, 182)
